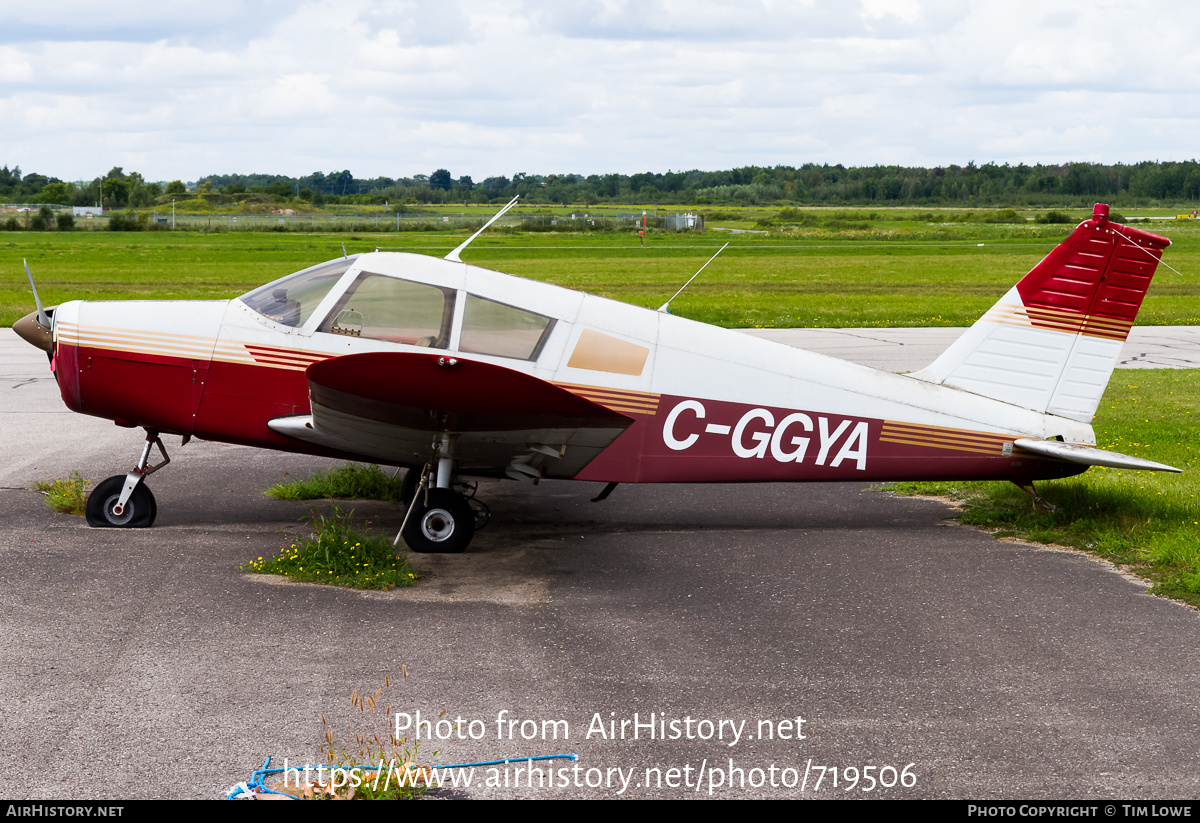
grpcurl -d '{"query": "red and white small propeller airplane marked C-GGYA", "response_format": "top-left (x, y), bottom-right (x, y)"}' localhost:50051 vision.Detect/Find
top-left (13, 200), bottom-right (1178, 552)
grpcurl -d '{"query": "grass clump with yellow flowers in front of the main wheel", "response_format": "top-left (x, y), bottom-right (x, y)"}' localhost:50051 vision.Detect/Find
top-left (241, 501), bottom-right (421, 589)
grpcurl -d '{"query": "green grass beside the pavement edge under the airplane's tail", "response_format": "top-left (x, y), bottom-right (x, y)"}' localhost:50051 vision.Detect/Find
top-left (889, 370), bottom-right (1200, 606)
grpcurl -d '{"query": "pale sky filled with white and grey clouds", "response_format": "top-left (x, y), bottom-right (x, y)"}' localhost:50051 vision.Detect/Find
top-left (0, 0), bottom-right (1200, 182)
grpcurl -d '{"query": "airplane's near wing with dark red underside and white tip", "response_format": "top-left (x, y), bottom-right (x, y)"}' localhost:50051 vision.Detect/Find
top-left (269, 352), bottom-right (634, 479)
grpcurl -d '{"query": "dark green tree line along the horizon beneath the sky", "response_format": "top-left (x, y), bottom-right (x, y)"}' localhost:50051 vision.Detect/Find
top-left (7, 160), bottom-right (1200, 209)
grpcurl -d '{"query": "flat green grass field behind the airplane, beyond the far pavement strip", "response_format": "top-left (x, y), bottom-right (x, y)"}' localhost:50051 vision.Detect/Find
top-left (0, 221), bottom-right (1200, 328)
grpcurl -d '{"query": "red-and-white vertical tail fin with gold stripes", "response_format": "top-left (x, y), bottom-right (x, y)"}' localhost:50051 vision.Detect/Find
top-left (911, 203), bottom-right (1171, 423)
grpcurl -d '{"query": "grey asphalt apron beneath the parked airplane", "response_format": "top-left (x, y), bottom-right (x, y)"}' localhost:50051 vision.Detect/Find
top-left (0, 330), bottom-right (1200, 799)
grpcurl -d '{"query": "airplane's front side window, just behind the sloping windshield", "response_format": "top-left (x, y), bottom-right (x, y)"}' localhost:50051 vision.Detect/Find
top-left (319, 272), bottom-right (455, 349)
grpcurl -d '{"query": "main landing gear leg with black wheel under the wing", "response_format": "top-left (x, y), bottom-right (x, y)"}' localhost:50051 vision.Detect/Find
top-left (396, 439), bottom-right (486, 554)
